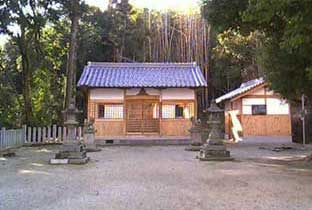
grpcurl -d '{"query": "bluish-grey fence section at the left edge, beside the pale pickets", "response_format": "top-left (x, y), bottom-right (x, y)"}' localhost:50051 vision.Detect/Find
top-left (0, 128), bottom-right (25, 151)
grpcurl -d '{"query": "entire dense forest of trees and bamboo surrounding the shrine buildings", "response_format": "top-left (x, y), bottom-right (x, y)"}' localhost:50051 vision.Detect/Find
top-left (0, 0), bottom-right (312, 127)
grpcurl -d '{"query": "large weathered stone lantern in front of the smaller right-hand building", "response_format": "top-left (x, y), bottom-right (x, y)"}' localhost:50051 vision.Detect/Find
top-left (199, 100), bottom-right (233, 161)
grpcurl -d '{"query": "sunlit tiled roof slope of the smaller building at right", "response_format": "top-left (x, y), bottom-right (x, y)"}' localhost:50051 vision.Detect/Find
top-left (216, 78), bottom-right (265, 103)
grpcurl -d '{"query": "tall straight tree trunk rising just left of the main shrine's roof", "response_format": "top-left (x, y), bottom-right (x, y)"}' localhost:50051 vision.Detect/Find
top-left (65, 0), bottom-right (80, 108)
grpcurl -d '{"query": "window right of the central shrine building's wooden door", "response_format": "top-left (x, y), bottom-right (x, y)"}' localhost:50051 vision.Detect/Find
top-left (162, 103), bottom-right (194, 119)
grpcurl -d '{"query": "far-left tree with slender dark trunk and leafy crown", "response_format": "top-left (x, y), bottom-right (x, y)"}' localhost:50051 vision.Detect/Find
top-left (0, 0), bottom-right (66, 124)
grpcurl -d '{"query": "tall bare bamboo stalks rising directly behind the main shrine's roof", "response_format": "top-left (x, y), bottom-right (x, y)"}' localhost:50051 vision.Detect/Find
top-left (100, 2), bottom-right (211, 109)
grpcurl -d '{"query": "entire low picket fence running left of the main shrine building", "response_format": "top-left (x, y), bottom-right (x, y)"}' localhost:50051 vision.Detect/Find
top-left (0, 125), bottom-right (83, 150)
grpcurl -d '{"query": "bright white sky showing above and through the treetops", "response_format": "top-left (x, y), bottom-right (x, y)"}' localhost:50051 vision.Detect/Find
top-left (0, 0), bottom-right (200, 46)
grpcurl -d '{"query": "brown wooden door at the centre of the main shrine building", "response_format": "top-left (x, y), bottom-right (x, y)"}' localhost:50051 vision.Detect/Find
top-left (127, 100), bottom-right (159, 134)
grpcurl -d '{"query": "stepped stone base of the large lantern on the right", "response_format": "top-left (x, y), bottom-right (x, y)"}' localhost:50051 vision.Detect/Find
top-left (199, 143), bottom-right (233, 161)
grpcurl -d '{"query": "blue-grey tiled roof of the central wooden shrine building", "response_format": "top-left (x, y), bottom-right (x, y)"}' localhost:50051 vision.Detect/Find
top-left (78, 62), bottom-right (207, 87)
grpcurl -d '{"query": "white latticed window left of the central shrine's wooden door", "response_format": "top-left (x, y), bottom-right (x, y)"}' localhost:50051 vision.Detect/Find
top-left (98, 104), bottom-right (123, 119)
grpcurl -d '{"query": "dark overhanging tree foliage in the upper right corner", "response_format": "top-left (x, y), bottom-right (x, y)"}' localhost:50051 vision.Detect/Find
top-left (243, 0), bottom-right (312, 99)
